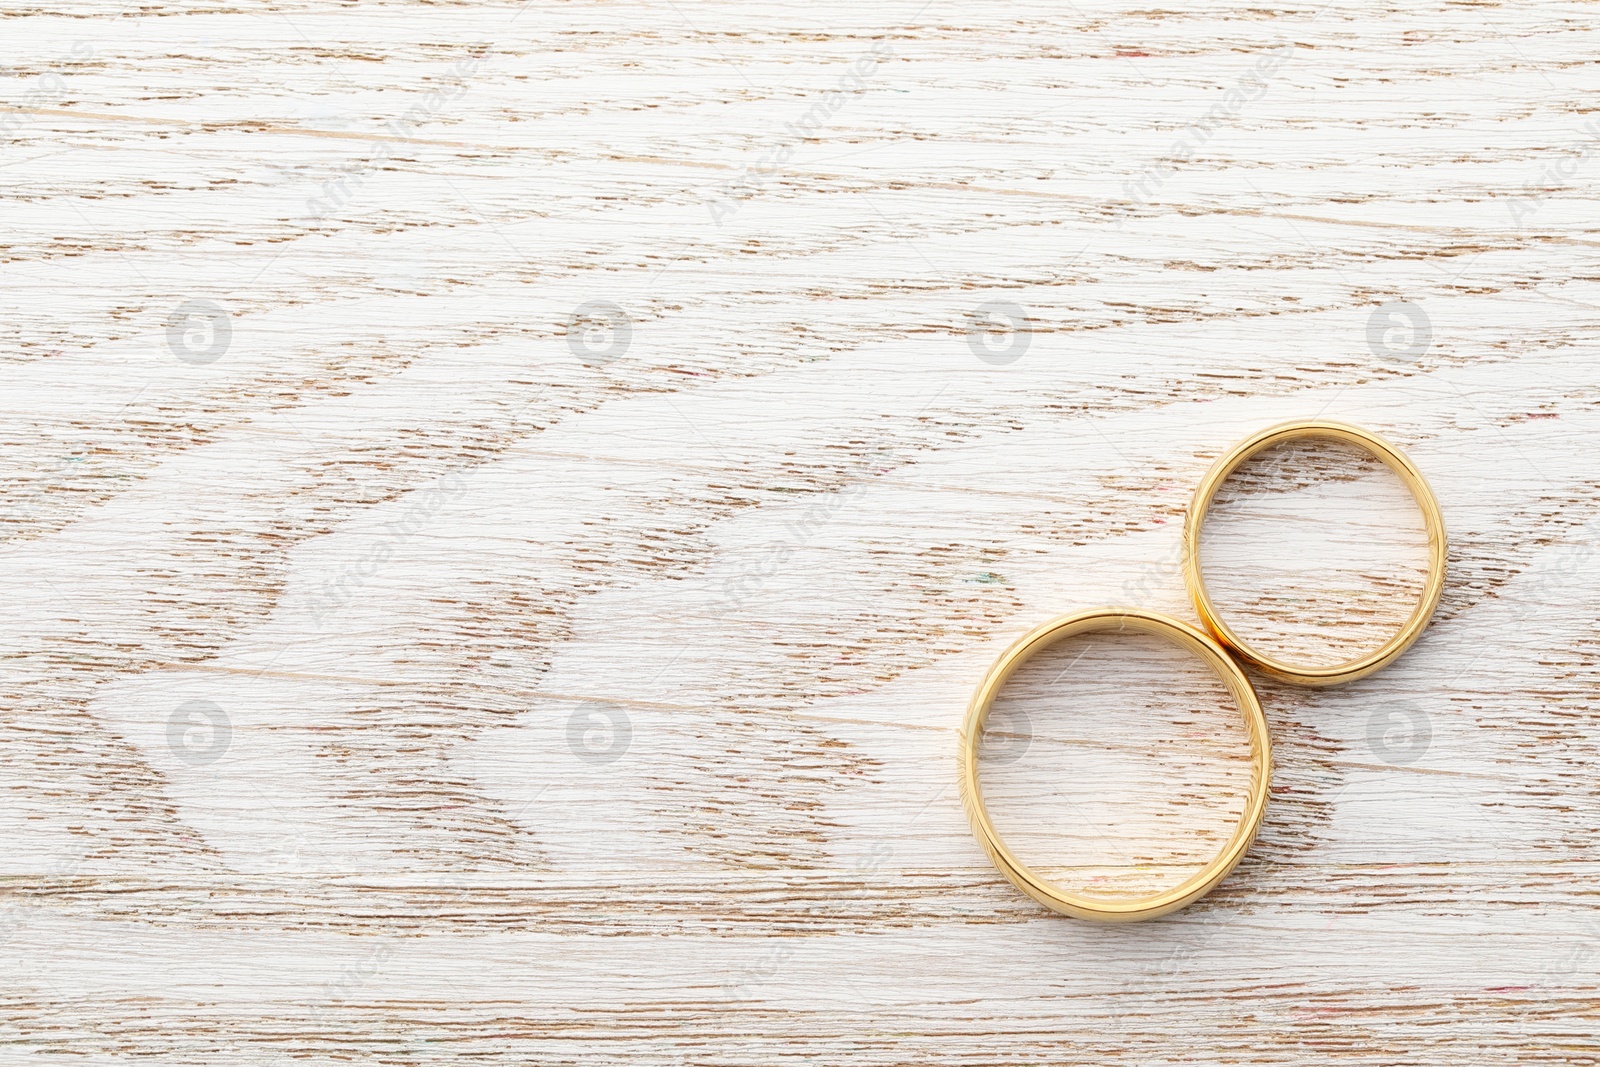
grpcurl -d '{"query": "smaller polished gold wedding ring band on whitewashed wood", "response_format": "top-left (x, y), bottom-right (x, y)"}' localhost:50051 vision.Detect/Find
top-left (1182, 419), bottom-right (1450, 686)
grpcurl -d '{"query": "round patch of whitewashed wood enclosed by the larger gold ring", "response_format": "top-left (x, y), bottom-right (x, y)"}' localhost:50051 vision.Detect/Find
top-left (978, 621), bottom-right (1251, 902)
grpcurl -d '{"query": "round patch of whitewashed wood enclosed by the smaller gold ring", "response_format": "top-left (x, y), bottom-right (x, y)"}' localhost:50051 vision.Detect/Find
top-left (1200, 437), bottom-right (1429, 669)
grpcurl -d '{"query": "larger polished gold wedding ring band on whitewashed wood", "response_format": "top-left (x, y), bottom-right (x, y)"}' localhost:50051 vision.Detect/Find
top-left (962, 608), bottom-right (1272, 923)
